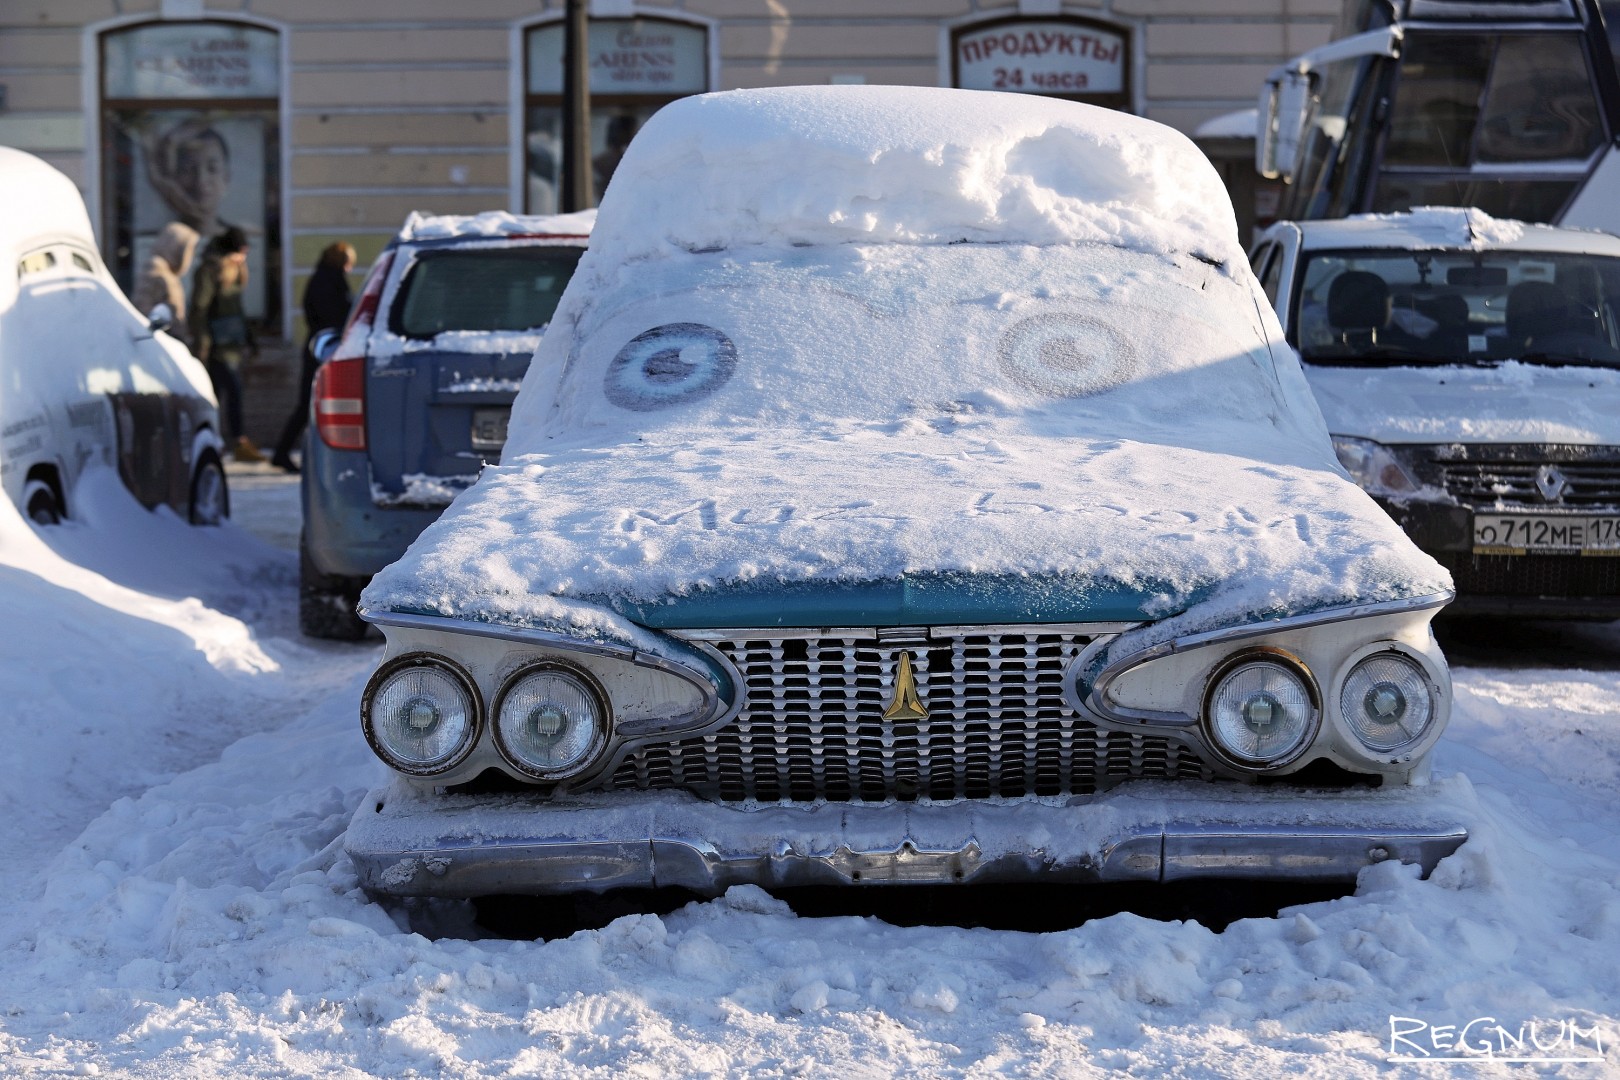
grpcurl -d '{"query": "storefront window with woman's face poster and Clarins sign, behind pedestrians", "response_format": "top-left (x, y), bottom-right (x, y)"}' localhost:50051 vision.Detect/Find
top-left (102, 23), bottom-right (280, 325)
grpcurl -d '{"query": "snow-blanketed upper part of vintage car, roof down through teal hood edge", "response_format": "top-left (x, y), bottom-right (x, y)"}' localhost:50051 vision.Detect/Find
top-left (363, 87), bottom-right (1448, 636)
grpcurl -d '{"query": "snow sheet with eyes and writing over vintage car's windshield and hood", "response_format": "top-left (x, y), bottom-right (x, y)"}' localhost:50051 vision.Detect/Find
top-left (365, 244), bottom-right (1450, 640)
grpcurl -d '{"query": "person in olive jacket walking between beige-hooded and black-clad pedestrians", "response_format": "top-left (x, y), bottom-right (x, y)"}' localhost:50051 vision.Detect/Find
top-left (188, 225), bottom-right (264, 461)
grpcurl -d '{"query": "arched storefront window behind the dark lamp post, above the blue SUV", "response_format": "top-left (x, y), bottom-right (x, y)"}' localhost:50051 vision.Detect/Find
top-left (523, 18), bottom-right (710, 214)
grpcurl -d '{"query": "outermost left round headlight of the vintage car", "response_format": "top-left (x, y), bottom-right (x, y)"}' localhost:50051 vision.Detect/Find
top-left (360, 654), bottom-right (478, 774)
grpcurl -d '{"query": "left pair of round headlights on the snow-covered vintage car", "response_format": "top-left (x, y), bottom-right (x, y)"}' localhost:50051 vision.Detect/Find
top-left (360, 653), bottom-right (611, 780)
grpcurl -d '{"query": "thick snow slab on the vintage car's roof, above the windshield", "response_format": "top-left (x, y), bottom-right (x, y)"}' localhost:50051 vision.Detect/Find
top-left (591, 86), bottom-right (1244, 266)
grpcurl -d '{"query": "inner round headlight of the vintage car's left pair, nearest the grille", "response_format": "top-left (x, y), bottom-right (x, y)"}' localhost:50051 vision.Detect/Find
top-left (494, 664), bottom-right (608, 780)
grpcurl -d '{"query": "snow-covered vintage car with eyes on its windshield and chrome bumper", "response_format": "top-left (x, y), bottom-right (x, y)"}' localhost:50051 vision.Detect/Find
top-left (347, 86), bottom-right (1466, 897)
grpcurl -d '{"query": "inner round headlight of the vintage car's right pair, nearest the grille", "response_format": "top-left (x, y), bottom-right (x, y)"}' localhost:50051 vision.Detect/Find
top-left (1204, 657), bottom-right (1317, 767)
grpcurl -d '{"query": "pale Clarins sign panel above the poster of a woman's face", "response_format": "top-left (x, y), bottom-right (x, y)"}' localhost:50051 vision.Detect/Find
top-left (102, 23), bottom-right (282, 100)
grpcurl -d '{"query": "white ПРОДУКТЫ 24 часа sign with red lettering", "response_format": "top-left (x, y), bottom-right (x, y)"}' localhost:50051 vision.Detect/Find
top-left (956, 19), bottom-right (1126, 94)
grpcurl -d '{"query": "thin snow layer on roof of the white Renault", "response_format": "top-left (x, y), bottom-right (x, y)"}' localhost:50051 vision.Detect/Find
top-left (1294, 206), bottom-right (1620, 256)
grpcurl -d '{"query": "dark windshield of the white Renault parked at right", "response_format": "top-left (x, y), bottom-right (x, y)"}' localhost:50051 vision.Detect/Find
top-left (1290, 249), bottom-right (1620, 366)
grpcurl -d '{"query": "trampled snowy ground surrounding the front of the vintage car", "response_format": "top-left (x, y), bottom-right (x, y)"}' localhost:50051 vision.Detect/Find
top-left (0, 470), bottom-right (1620, 1077)
